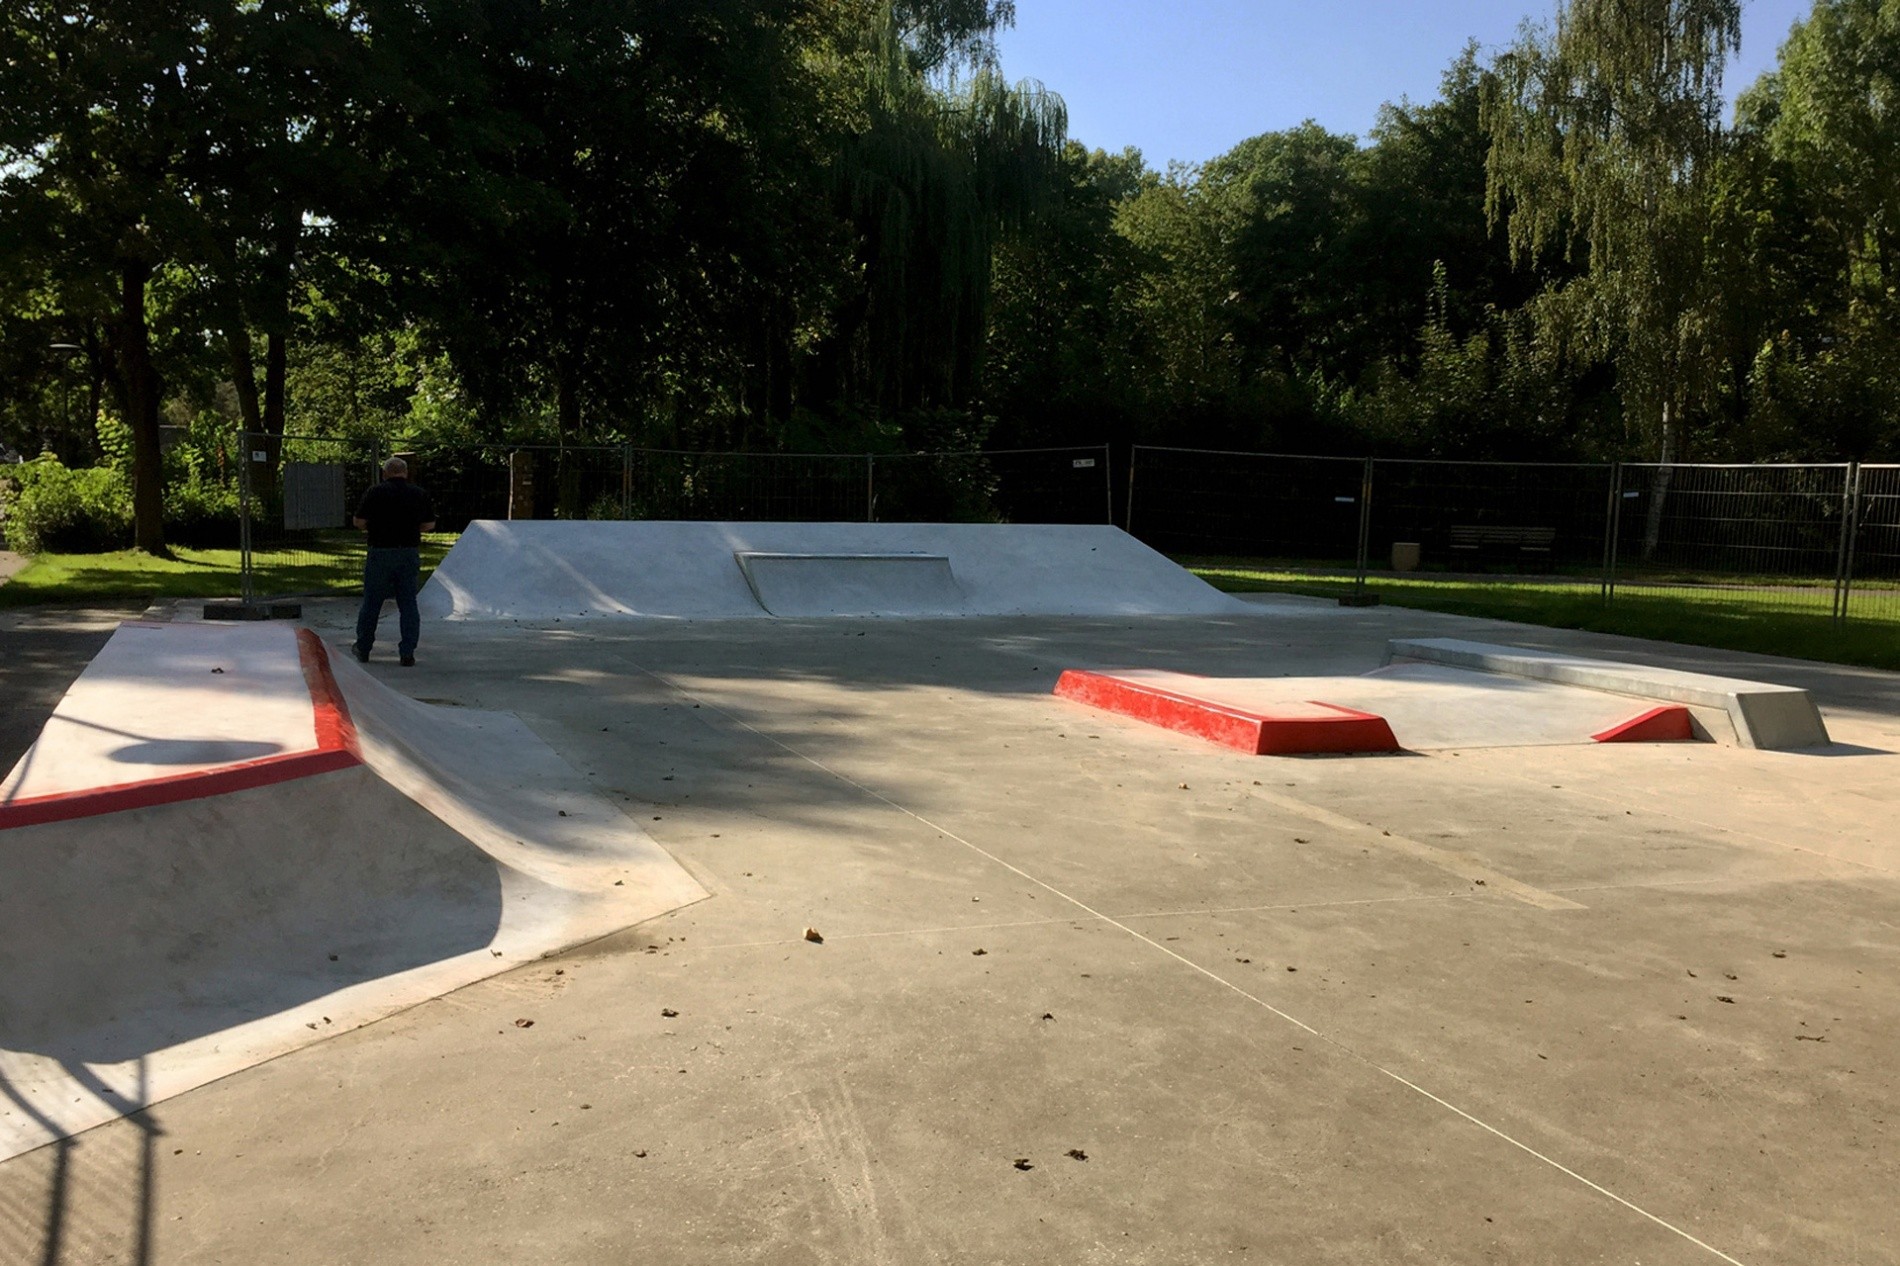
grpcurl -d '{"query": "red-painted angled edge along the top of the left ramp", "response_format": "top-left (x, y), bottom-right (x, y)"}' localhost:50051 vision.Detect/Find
top-left (0, 625), bottom-right (363, 831)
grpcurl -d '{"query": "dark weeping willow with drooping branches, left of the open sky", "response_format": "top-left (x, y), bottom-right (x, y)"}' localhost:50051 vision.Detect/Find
top-left (817, 10), bottom-right (1068, 431)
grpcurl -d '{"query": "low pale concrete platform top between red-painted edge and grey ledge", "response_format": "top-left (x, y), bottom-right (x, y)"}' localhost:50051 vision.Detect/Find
top-left (1071, 663), bottom-right (1694, 751)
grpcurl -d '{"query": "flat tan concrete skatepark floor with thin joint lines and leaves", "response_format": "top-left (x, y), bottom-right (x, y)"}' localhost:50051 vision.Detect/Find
top-left (0, 601), bottom-right (1900, 1266)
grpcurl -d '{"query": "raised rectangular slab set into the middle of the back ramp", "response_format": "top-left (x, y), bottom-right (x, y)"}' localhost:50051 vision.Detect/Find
top-left (733, 549), bottom-right (965, 616)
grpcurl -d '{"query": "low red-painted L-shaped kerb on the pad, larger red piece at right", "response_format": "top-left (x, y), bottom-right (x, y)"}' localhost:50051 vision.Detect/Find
top-left (1055, 669), bottom-right (1400, 757)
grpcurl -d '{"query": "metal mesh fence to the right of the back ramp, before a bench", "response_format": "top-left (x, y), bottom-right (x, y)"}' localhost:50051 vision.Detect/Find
top-left (1127, 445), bottom-right (1900, 620)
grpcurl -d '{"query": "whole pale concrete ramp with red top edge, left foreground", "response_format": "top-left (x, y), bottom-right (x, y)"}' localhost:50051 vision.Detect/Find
top-left (0, 623), bottom-right (705, 1158)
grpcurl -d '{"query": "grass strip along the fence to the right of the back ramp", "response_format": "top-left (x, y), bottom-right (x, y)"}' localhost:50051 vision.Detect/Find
top-left (1176, 557), bottom-right (1900, 669)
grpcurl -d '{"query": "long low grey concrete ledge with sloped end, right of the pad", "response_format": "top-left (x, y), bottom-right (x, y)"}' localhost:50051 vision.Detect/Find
top-left (1385, 637), bottom-right (1832, 751)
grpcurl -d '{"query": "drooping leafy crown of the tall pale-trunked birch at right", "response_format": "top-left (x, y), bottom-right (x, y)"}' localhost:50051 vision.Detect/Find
top-left (1480, 0), bottom-right (1740, 475)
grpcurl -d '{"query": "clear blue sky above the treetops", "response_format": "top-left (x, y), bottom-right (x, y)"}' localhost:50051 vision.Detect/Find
top-left (1001, 0), bottom-right (1811, 169)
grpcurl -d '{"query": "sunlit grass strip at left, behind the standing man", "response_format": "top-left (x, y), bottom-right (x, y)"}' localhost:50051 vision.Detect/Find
top-left (0, 532), bottom-right (454, 606)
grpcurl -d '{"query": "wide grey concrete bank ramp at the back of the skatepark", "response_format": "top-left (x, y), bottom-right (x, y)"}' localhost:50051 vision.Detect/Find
top-left (422, 521), bottom-right (1252, 620)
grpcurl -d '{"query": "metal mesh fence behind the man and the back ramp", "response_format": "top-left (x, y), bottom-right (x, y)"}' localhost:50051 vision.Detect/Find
top-left (239, 435), bottom-right (1113, 603)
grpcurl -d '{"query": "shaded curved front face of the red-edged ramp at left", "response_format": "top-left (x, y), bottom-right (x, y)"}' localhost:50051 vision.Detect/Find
top-left (0, 768), bottom-right (502, 1072)
